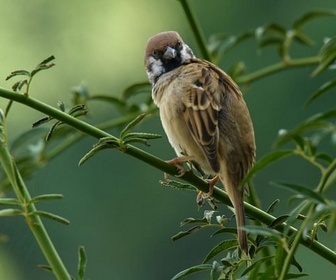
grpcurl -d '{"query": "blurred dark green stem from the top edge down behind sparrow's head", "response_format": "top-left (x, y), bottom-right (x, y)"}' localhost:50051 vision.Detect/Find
top-left (179, 0), bottom-right (212, 61)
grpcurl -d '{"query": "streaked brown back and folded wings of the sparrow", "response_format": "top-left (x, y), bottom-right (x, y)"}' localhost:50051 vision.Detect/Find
top-left (181, 59), bottom-right (255, 182)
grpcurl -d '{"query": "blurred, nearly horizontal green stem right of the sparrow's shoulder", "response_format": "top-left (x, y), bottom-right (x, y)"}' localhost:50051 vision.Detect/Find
top-left (236, 56), bottom-right (320, 84)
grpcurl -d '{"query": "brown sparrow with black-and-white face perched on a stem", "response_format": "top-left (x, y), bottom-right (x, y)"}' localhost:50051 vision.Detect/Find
top-left (144, 31), bottom-right (256, 256)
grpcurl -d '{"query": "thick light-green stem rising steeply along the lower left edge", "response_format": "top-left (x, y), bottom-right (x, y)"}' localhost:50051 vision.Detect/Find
top-left (0, 112), bottom-right (71, 280)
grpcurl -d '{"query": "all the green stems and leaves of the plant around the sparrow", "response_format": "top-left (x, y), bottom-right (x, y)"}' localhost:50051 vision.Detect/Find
top-left (0, 0), bottom-right (336, 279)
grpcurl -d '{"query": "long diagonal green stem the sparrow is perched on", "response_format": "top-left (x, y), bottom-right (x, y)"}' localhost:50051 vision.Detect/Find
top-left (0, 88), bottom-right (336, 265)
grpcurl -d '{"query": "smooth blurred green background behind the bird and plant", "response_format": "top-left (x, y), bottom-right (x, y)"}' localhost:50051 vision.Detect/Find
top-left (0, 0), bottom-right (336, 280)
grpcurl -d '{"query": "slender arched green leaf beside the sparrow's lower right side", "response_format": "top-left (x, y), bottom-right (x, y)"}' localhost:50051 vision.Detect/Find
top-left (241, 150), bottom-right (293, 186)
